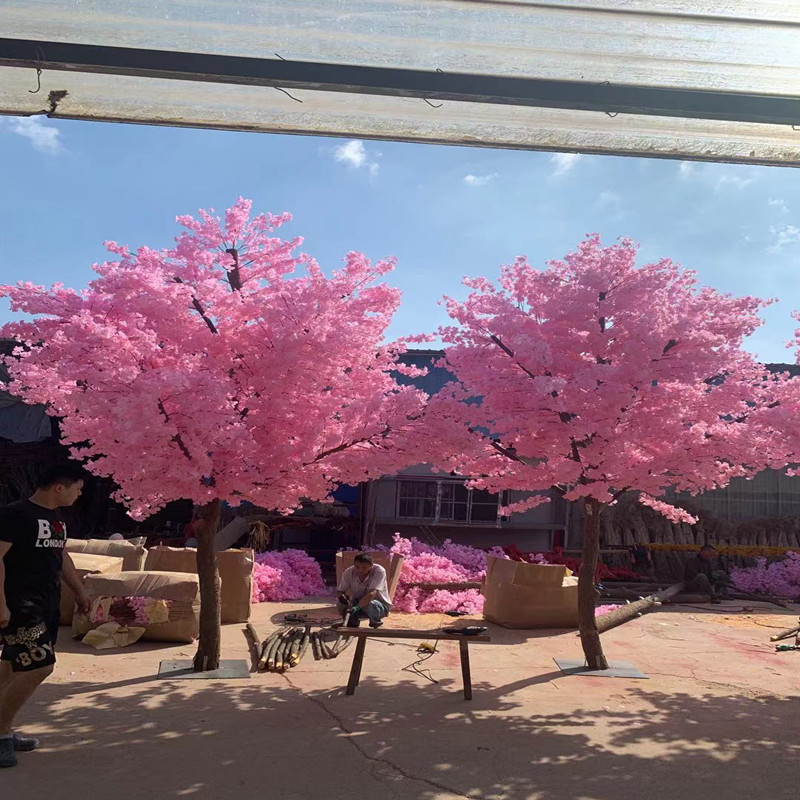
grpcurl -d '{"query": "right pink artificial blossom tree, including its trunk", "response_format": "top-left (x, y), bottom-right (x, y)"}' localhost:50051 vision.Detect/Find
top-left (428, 235), bottom-right (791, 668)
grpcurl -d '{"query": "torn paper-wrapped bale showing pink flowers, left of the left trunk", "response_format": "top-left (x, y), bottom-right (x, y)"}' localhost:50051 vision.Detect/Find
top-left (72, 572), bottom-right (200, 643)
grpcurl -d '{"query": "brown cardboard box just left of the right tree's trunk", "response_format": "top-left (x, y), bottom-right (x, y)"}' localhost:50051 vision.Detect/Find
top-left (483, 556), bottom-right (578, 628)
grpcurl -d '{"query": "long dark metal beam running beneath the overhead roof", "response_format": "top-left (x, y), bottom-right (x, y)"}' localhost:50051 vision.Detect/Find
top-left (0, 38), bottom-right (800, 125)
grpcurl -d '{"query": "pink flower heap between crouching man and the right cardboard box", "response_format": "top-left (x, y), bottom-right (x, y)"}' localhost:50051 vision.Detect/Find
top-left (377, 533), bottom-right (507, 614)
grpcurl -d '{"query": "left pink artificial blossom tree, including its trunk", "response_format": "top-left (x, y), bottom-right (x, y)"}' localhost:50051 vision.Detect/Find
top-left (0, 199), bottom-right (425, 670)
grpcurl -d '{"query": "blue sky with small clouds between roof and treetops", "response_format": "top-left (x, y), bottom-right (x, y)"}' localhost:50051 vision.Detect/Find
top-left (0, 118), bottom-right (800, 361)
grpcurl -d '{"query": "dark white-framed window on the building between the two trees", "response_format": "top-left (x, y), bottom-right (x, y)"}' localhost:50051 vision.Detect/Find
top-left (397, 480), bottom-right (501, 525)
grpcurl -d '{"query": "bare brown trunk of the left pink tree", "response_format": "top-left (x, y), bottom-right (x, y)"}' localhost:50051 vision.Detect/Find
top-left (194, 500), bottom-right (222, 672)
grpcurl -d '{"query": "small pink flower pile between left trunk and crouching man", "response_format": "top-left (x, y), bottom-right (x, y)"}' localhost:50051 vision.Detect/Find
top-left (253, 550), bottom-right (327, 603)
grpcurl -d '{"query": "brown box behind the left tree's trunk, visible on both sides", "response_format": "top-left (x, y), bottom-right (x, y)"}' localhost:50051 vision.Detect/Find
top-left (144, 547), bottom-right (254, 624)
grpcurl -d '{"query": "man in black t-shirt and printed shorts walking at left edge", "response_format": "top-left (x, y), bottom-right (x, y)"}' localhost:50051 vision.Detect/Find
top-left (0, 464), bottom-right (89, 767)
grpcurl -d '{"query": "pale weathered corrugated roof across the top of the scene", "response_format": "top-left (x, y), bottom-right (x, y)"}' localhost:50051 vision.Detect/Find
top-left (0, 0), bottom-right (800, 164)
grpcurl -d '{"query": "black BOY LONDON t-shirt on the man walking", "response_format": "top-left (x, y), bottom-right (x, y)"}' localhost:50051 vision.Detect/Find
top-left (0, 500), bottom-right (67, 618)
